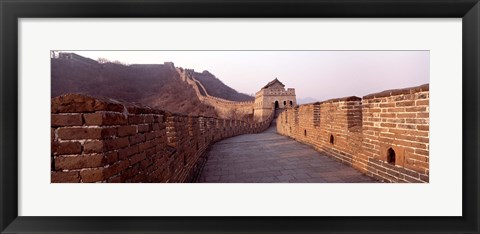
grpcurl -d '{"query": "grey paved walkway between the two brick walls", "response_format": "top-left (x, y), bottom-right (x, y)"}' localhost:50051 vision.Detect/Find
top-left (198, 120), bottom-right (376, 183)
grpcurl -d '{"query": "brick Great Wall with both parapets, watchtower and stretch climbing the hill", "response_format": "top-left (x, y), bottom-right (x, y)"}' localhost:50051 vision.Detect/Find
top-left (51, 56), bottom-right (430, 183)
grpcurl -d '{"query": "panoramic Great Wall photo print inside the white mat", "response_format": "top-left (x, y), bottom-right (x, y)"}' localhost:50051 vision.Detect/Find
top-left (50, 50), bottom-right (430, 183)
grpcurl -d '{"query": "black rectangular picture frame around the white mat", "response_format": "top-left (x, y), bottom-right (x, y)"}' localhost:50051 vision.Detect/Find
top-left (0, 0), bottom-right (480, 233)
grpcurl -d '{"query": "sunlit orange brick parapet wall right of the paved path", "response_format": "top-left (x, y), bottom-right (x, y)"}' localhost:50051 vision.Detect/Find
top-left (277, 84), bottom-right (429, 182)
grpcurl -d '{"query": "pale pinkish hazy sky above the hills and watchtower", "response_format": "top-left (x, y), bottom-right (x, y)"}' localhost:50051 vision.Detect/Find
top-left (61, 51), bottom-right (430, 101)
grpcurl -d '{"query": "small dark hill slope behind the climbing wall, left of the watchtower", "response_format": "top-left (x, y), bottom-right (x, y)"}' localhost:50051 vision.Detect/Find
top-left (193, 71), bottom-right (255, 101)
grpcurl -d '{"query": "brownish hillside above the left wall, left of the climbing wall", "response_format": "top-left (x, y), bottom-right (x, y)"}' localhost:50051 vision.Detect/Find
top-left (51, 59), bottom-right (216, 116)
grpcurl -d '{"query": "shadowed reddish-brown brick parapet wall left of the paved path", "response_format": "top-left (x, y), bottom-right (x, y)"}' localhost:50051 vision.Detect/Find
top-left (51, 94), bottom-right (272, 183)
